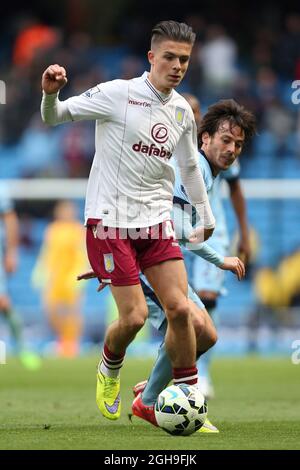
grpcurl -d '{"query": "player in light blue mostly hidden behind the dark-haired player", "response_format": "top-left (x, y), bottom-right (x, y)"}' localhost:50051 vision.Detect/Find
top-left (184, 95), bottom-right (250, 399)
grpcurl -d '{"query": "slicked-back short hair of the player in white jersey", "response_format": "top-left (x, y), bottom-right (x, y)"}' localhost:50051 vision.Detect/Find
top-left (151, 20), bottom-right (196, 48)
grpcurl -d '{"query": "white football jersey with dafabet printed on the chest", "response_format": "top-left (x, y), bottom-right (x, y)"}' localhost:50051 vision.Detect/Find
top-left (65, 72), bottom-right (206, 228)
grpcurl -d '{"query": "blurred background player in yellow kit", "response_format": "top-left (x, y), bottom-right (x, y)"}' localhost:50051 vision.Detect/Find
top-left (33, 201), bottom-right (87, 357)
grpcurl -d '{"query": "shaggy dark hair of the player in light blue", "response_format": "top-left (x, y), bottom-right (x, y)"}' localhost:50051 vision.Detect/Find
top-left (198, 99), bottom-right (256, 146)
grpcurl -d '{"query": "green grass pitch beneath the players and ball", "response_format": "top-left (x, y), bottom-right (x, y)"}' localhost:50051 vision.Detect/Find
top-left (0, 357), bottom-right (300, 450)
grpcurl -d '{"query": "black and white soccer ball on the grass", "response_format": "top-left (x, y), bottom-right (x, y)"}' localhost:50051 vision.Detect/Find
top-left (154, 384), bottom-right (207, 436)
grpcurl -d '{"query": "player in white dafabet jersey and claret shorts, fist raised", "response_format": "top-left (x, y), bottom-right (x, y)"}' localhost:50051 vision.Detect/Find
top-left (41, 21), bottom-right (216, 419)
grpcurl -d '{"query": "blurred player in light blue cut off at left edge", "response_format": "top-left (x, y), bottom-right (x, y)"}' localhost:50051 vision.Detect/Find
top-left (0, 183), bottom-right (40, 369)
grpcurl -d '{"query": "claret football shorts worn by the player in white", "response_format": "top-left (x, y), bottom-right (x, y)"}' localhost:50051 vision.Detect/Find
top-left (86, 219), bottom-right (183, 286)
